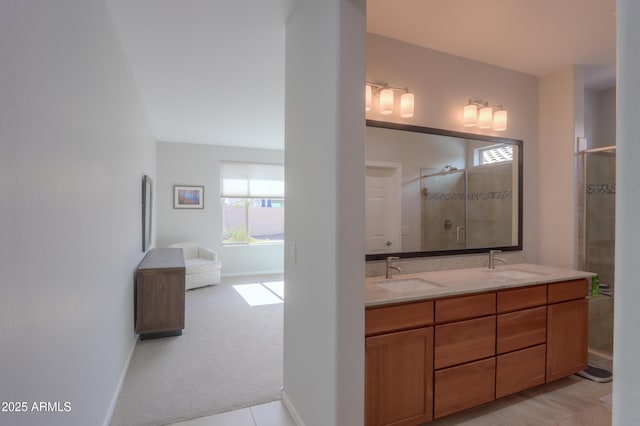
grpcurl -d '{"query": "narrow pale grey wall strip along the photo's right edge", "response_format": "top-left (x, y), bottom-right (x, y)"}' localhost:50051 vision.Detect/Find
top-left (613, 0), bottom-right (640, 426)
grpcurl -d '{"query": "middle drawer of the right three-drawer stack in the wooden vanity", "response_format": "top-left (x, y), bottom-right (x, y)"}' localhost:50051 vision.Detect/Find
top-left (496, 306), bottom-right (547, 354)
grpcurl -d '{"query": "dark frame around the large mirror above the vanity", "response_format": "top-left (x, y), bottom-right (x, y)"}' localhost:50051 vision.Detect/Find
top-left (365, 120), bottom-right (524, 261)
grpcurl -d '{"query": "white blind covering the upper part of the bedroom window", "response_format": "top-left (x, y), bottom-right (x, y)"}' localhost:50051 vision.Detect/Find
top-left (220, 161), bottom-right (284, 198)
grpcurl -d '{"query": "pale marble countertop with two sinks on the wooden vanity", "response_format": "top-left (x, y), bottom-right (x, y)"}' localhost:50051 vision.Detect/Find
top-left (365, 263), bottom-right (595, 306)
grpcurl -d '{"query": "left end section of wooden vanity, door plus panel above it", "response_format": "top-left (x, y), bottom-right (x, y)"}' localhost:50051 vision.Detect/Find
top-left (365, 301), bottom-right (433, 426)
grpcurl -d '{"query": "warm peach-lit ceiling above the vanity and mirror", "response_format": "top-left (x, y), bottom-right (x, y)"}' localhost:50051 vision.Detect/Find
top-left (367, 0), bottom-right (616, 88)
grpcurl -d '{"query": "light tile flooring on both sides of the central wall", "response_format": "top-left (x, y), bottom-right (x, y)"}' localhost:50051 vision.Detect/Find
top-left (172, 376), bottom-right (612, 426)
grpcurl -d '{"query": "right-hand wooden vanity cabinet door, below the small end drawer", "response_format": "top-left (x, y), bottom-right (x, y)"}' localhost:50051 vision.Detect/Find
top-left (547, 299), bottom-right (589, 382)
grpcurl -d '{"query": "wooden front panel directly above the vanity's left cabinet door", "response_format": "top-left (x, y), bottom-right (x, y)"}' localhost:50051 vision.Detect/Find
top-left (365, 300), bottom-right (433, 336)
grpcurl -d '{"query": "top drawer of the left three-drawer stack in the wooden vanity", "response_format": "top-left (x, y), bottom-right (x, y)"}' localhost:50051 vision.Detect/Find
top-left (436, 293), bottom-right (496, 323)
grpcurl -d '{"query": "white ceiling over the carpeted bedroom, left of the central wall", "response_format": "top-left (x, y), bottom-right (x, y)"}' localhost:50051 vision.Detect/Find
top-left (107, 0), bottom-right (287, 149)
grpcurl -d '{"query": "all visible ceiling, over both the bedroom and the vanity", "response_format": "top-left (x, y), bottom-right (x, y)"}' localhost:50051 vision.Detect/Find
top-left (107, 0), bottom-right (616, 149)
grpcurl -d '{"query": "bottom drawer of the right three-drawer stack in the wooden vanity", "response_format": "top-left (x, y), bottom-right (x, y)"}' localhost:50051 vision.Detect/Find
top-left (496, 344), bottom-right (547, 398)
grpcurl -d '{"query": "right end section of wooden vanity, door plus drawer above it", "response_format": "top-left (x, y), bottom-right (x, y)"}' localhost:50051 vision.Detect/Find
top-left (547, 279), bottom-right (589, 382)
